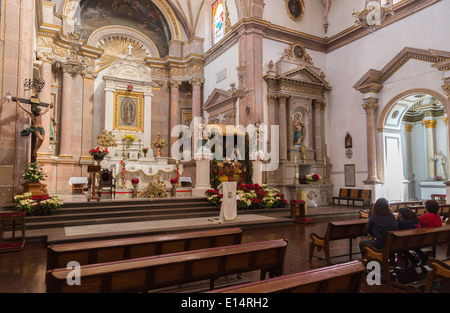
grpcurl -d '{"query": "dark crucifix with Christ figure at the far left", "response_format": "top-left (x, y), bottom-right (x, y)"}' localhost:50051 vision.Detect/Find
top-left (7, 97), bottom-right (53, 162)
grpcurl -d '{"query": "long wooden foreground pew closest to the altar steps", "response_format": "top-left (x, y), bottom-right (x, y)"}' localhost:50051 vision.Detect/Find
top-left (47, 227), bottom-right (242, 269)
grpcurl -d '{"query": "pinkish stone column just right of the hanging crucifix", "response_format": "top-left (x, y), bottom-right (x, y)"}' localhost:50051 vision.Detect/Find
top-left (59, 68), bottom-right (73, 159)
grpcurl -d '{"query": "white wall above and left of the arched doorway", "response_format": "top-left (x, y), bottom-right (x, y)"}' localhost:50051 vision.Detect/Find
top-left (326, 1), bottom-right (450, 194)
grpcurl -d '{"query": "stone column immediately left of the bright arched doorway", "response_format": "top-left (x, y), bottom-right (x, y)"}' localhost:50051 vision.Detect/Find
top-left (362, 98), bottom-right (380, 184)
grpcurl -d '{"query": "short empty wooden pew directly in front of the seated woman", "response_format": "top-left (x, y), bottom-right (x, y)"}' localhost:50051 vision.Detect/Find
top-left (309, 219), bottom-right (367, 265)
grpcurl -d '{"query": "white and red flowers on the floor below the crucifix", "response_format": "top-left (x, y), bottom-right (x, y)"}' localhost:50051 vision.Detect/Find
top-left (14, 192), bottom-right (63, 216)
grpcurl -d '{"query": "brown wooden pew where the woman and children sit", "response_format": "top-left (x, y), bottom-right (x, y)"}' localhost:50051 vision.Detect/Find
top-left (362, 225), bottom-right (450, 285)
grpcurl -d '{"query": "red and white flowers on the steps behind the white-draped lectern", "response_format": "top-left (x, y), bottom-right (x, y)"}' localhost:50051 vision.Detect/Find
top-left (205, 184), bottom-right (287, 210)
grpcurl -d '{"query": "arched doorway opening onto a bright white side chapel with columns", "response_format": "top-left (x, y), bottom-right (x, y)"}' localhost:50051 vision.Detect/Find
top-left (379, 89), bottom-right (449, 201)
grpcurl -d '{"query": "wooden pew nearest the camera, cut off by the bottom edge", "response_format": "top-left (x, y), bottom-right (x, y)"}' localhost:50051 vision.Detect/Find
top-left (208, 261), bottom-right (365, 294)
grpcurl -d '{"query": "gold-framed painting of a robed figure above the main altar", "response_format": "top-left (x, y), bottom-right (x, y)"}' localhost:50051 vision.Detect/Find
top-left (113, 90), bottom-right (144, 132)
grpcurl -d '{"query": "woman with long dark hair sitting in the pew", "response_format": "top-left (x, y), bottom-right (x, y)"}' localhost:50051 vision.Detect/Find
top-left (359, 198), bottom-right (398, 254)
